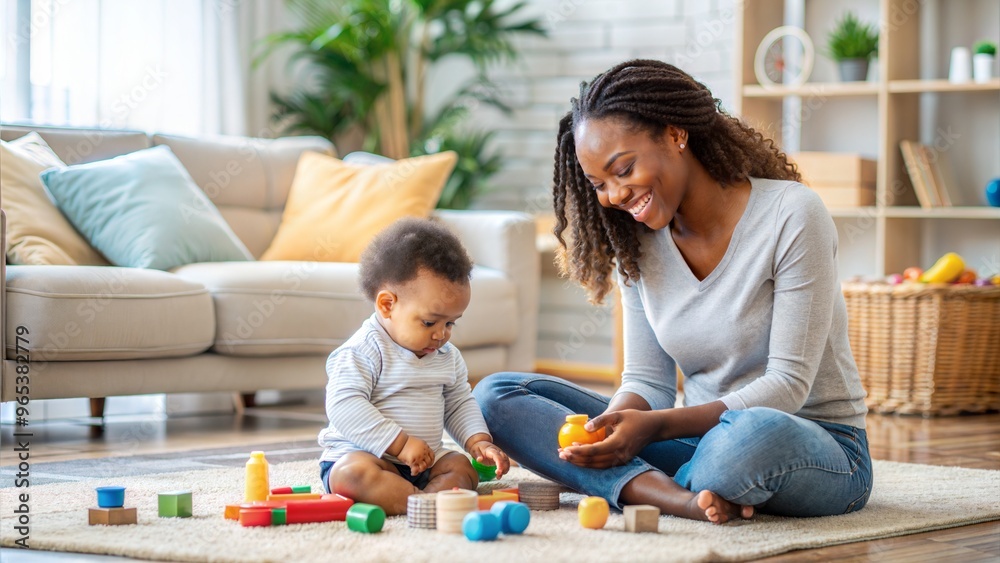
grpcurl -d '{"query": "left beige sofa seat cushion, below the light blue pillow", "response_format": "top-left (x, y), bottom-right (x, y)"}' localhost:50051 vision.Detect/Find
top-left (5, 266), bottom-right (215, 362)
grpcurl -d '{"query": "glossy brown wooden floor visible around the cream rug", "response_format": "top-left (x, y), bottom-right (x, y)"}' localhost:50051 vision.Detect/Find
top-left (0, 389), bottom-right (1000, 563)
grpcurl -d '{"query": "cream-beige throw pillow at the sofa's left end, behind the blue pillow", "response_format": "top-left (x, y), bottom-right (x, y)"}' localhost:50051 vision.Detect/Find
top-left (0, 132), bottom-right (108, 266)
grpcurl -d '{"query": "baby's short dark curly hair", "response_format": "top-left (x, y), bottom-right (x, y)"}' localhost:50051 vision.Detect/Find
top-left (359, 217), bottom-right (472, 301)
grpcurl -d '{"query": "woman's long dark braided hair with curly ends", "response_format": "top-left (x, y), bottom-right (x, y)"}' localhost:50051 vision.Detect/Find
top-left (552, 60), bottom-right (801, 303)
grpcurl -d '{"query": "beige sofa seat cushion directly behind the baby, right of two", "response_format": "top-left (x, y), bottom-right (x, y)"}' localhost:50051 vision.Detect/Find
top-left (174, 261), bottom-right (517, 356)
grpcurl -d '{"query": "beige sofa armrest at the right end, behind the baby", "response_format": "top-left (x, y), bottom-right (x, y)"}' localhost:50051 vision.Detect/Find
top-left (435, 210), bottom-right (541, 372)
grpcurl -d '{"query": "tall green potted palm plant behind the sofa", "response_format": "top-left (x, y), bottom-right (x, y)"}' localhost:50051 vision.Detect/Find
top-left (256, 0), bottom-right (545, 208)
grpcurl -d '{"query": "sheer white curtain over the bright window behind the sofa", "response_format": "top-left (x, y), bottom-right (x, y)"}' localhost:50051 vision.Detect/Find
top-left (0, 0), bottom-right (284, 135)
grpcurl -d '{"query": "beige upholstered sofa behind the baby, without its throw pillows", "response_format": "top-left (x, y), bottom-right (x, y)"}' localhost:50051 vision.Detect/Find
top-left (0, 126), bottom-right (539, 415)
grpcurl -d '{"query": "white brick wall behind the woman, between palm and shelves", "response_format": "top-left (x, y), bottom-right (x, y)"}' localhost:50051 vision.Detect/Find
top-left (428, 0), bottom-right (734, 364)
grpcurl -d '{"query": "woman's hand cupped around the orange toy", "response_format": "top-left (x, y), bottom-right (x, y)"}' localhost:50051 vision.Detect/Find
top-left (559, 409), bottom-right (660, 469)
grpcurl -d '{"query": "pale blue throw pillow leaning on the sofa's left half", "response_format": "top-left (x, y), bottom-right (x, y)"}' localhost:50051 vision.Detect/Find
top-left (41, 145), bottom-right (253, 270)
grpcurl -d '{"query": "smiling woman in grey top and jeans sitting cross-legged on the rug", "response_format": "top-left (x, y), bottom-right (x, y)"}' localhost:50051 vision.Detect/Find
top-left (475, 60), bottom-right (872, 523)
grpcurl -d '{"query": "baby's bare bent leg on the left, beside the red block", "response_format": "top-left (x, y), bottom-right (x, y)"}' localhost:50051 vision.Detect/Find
top-left (330, 452), bottom-right (420, 516)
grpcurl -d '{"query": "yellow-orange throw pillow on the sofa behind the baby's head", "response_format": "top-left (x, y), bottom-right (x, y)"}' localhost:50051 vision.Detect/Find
top-left (260, 151), bottom-right (458, 262)
